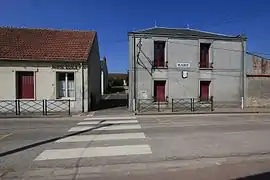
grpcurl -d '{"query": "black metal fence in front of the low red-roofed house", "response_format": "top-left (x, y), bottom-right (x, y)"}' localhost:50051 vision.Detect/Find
top-left (0, 99), bottom-right (71, 115)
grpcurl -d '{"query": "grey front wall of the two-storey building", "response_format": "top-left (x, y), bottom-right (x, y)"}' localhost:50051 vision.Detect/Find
top-left (129, 33), bottom-right (244, 107)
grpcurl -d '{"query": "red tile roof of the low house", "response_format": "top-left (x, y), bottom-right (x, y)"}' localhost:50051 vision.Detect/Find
top-left (0, 27), bottom-right (96, 61)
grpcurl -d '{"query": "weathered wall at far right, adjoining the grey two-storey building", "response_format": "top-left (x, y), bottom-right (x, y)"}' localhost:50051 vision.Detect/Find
top-left (246, 54), bottom-right (270, 107)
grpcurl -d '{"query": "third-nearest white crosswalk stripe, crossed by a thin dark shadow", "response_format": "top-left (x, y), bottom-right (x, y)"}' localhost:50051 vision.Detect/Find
top-left (68, 124), bottom-right (142, 132)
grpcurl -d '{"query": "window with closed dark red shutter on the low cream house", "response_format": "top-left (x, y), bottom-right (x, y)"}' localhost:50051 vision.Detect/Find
top-left (16, 71), bottom-right (35, 99)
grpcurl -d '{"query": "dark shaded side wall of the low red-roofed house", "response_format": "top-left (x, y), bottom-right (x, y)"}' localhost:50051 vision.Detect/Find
top-left (88, 33), bottom-right (101, 110)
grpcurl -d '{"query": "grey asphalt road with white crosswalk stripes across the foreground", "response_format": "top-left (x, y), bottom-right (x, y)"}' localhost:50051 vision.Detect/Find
top-left (0, 114), bottom-right (270, 179)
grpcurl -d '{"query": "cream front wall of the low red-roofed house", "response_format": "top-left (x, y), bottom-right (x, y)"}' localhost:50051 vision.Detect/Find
top-left (0, 61), bottom-right (88, 112)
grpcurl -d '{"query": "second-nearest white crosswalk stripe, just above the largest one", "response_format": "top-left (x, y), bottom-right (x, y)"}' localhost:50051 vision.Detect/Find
top-left (56, 133), bottom-right (145, 142)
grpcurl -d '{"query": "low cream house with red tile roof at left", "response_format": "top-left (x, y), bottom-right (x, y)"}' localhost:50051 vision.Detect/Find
top-left (0, 28), bottom-right (101, 112)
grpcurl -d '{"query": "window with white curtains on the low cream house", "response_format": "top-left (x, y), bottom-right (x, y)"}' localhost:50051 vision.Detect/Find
top-left (56, 72), bottom-right (75, 98)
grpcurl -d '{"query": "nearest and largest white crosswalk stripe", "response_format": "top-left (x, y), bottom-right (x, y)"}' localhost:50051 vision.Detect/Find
top-left (35, 144), bottom-right (152, 161)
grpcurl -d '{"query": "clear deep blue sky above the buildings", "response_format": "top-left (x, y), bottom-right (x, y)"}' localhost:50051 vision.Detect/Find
top-left (0, 0), bottom-right (270, 72)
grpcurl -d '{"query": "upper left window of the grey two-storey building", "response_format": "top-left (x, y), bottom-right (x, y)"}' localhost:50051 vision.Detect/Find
top-left (154, 41), bottom-right (167, 68)
